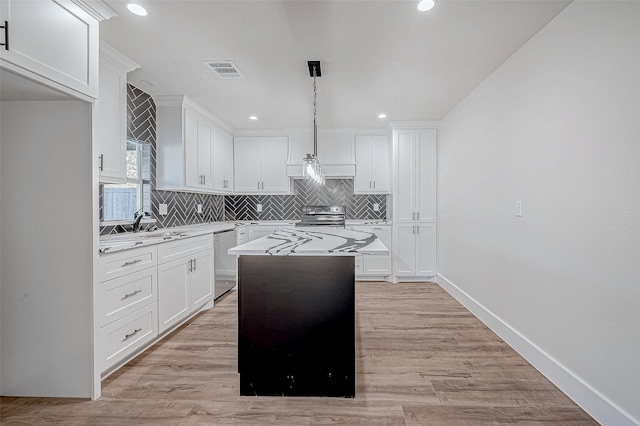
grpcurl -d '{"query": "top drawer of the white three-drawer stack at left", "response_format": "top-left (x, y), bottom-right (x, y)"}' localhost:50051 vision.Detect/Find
top-left (96, 246), bottom-right (158, 282)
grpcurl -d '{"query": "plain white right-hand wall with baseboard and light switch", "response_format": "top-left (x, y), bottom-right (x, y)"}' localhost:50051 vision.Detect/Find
top-left (438, 1), bottom-right (640, 425)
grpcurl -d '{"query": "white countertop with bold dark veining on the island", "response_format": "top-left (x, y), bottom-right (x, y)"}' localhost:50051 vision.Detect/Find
top-left (228, 227), bottom-right (389, 256)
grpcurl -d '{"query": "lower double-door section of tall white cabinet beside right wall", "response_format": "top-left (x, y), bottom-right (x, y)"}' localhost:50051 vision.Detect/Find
top-left (393, 223), bottom-right (436, 278)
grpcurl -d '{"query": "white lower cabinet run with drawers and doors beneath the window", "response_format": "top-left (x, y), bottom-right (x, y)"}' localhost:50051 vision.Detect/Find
top-left (95, 234), bottom-right (214, 373)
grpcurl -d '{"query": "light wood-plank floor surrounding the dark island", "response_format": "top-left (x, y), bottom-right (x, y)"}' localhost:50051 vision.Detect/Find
top-left (0, 282), bottom-right (597, 426)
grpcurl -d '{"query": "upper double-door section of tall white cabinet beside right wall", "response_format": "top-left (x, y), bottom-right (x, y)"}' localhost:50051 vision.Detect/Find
top-left (393, 129), bottom-right (436, 222)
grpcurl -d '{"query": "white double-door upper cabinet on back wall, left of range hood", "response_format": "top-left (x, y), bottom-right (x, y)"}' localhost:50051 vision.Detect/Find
top-left (233, 136), bottom-right (290, 194)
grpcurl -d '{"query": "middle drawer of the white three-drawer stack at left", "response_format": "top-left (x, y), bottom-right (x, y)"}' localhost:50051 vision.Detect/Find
top-left (96, 268), bottom-right (158, 326)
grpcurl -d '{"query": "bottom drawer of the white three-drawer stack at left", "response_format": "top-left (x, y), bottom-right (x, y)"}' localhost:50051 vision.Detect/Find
top-left (100, 302), bottom-right (158, 371)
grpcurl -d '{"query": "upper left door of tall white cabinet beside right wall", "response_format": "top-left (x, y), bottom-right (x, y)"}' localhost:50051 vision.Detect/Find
top-left (393, 131), bottom-right (418, 222)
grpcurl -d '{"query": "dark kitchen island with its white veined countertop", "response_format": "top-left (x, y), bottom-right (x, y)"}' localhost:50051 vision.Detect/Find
top-left (229, 228), bottom-right (388, 398)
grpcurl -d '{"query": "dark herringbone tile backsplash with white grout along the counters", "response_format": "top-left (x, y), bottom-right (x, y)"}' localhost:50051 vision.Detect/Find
top-left (100, 85), bottom-right (387, 235)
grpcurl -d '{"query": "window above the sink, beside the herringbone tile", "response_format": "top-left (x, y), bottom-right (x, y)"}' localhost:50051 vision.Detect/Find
top-left (102, 140), bottom-right (151, 222)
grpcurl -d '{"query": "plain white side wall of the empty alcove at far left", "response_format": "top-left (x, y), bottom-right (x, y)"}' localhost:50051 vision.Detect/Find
top-left (0, 101), bottom-right (97, 398)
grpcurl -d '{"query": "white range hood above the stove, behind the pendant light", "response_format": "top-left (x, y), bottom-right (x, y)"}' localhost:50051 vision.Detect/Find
top-left (287, 129), bottom-right (356, 179)
